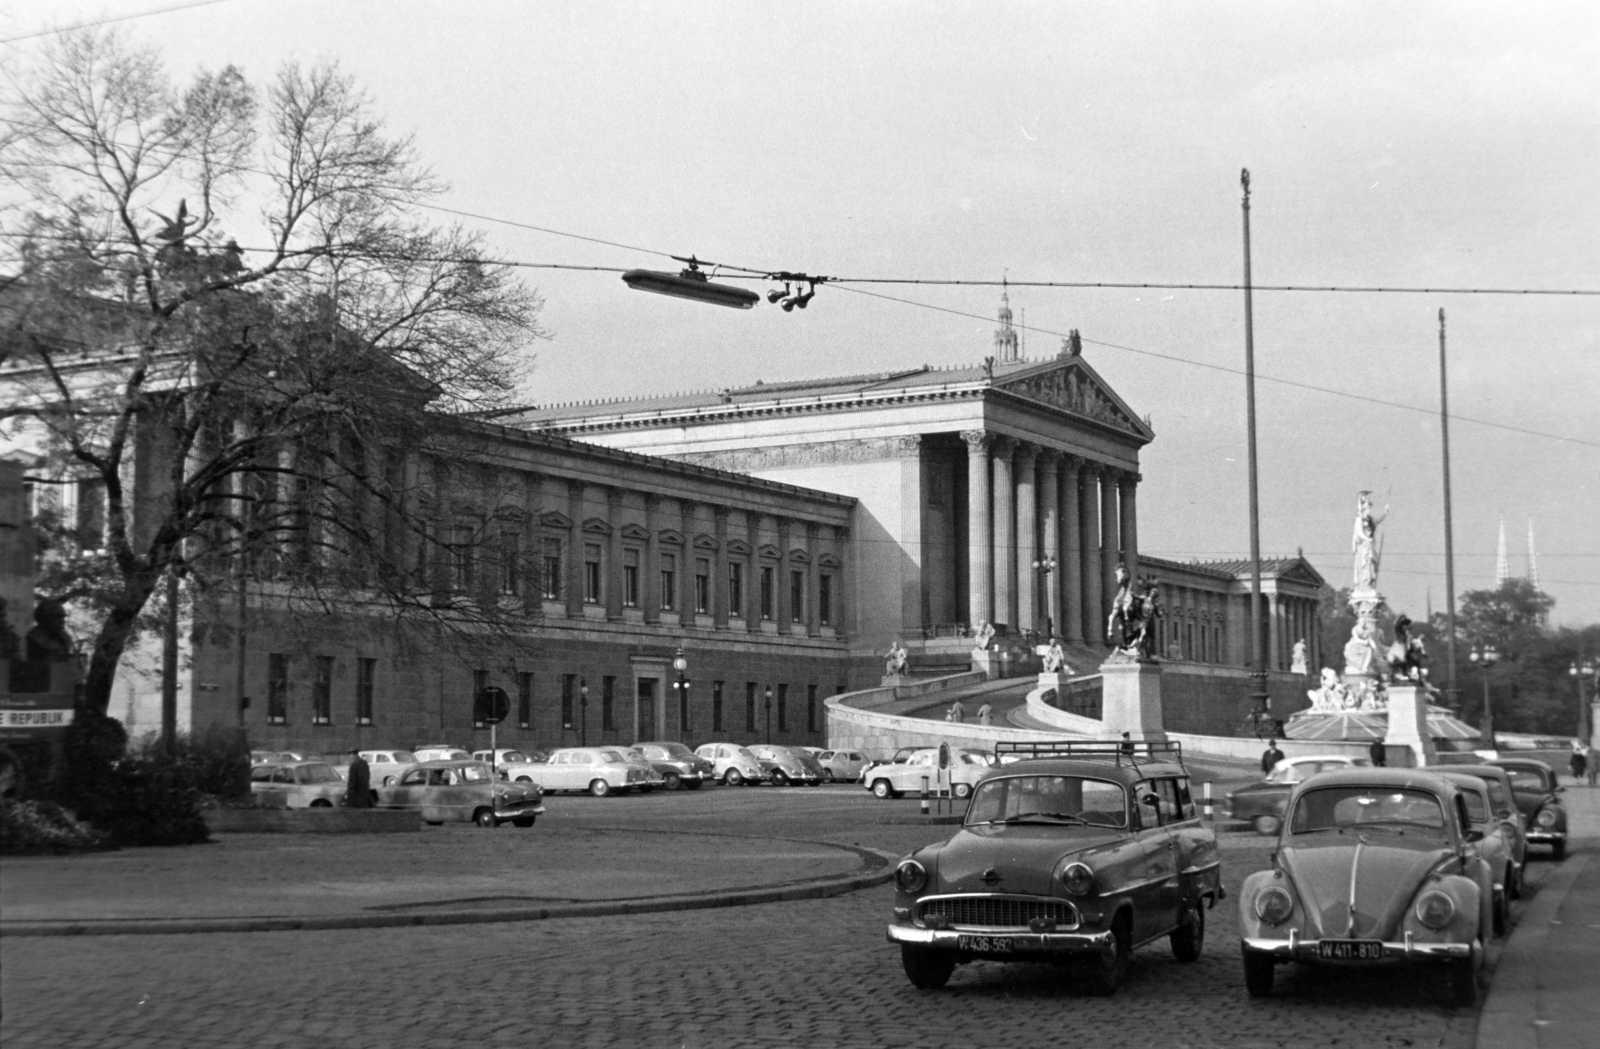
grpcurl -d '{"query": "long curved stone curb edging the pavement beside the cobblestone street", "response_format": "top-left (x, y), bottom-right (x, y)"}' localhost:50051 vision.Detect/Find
top-left (0, 846), bottom-right (898, 939)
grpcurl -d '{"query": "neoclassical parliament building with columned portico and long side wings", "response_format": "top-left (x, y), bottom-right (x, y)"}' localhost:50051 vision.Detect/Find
top-left (21, 301), bottom-right (1322, 752)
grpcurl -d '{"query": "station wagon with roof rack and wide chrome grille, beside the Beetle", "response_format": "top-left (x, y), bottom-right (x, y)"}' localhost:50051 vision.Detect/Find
top-left (880, 742), bottom-right (1222, 995)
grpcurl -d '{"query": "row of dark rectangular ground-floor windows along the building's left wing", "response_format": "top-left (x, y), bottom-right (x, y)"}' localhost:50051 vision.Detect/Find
top-left (267, 652), bottom-right (845, 734)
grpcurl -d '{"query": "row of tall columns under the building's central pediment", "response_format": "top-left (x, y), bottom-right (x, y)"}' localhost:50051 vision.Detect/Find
top-left (962, 430), bottom-right (1139, 643)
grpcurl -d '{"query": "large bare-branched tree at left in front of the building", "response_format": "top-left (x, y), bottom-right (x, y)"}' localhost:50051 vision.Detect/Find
top-left (0, 29), bottom-right (544, 713)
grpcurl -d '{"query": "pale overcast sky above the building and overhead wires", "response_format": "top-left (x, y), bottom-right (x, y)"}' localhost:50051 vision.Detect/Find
top-left (9, 0), bottom-right (1600, 625)
